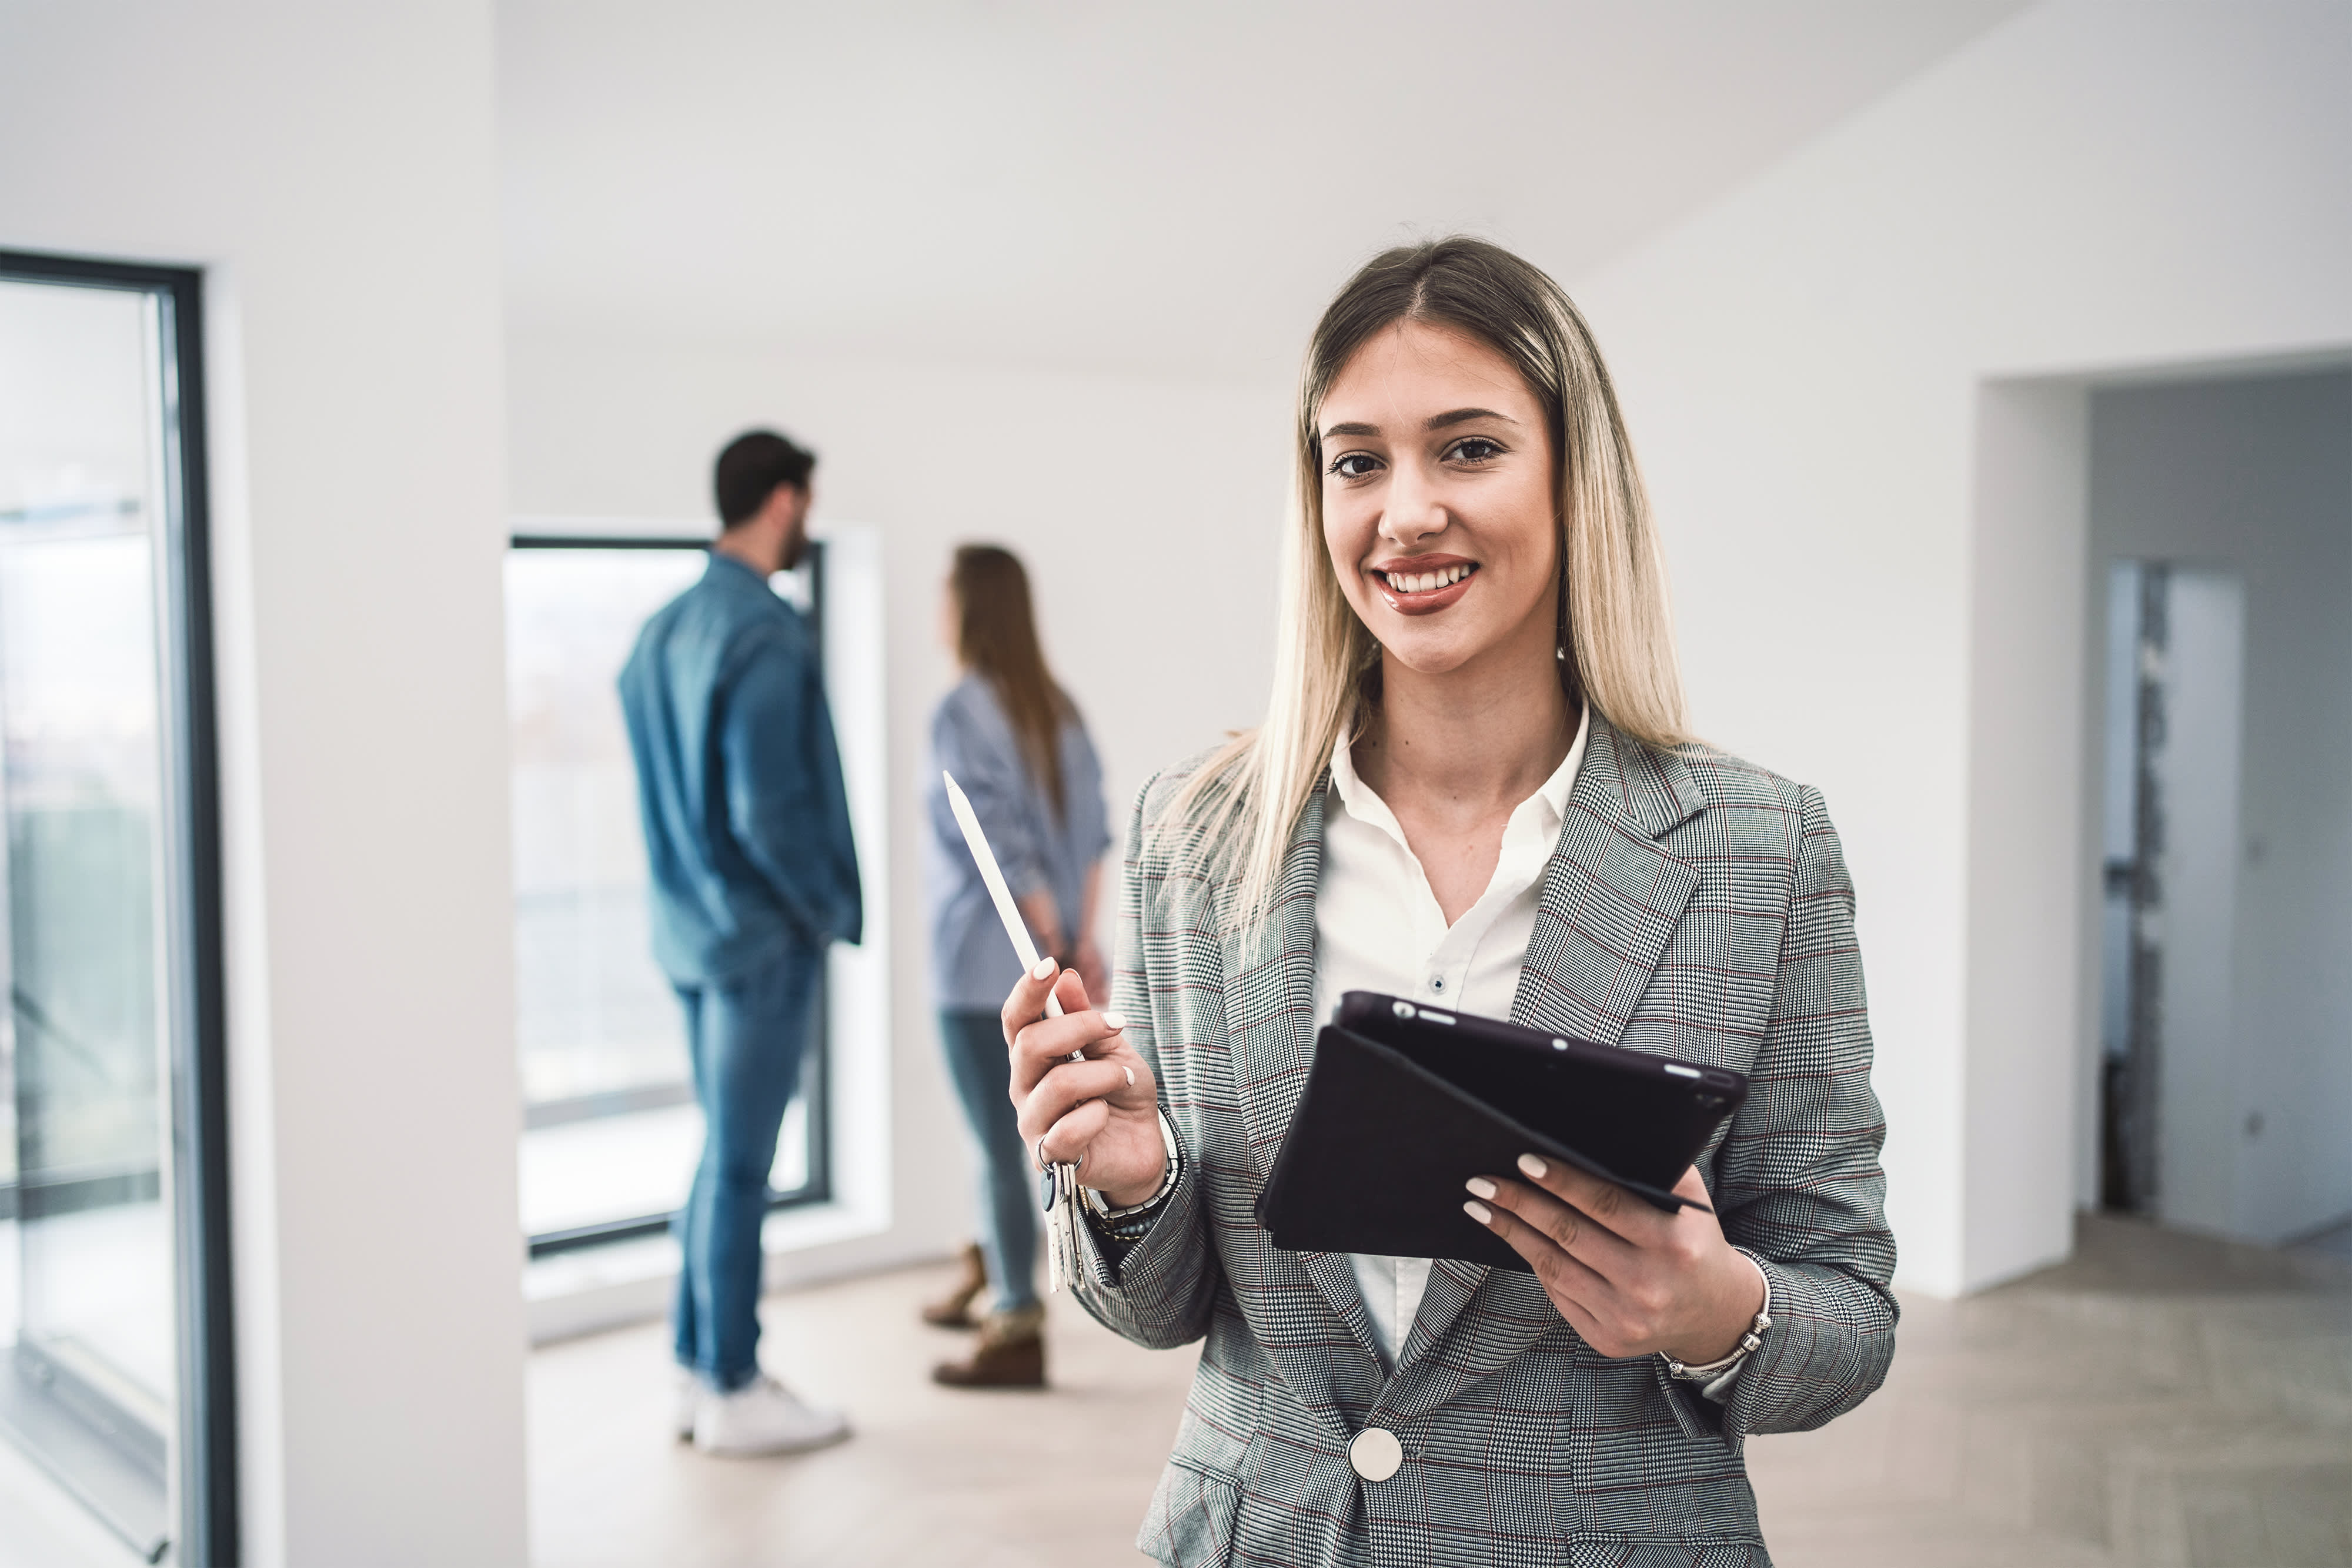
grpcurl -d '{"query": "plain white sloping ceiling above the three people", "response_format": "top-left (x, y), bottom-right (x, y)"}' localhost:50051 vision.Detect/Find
top-left (499, 0), bottom-right (2025, 383)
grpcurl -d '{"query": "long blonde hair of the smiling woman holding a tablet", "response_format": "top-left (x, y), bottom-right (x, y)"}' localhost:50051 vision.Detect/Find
top-left (1169, 235), bottom-right (1689, 921)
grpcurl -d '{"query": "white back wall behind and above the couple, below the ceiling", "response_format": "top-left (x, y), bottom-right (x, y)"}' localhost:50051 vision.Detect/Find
top-left (508, 332), bottom-right (1289, 1288)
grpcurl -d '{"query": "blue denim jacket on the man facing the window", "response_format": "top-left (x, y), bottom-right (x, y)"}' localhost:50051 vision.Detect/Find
top-left (621, 553), bottom-right (863, 985)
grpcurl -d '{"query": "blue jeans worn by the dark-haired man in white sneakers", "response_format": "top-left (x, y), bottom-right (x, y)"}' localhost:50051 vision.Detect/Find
top-left (670, 947), bottom-right (823, 1392)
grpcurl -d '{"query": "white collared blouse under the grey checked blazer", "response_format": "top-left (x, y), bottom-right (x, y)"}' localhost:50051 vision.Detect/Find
top-left (1315, 710), bottom-right (1590, 1368)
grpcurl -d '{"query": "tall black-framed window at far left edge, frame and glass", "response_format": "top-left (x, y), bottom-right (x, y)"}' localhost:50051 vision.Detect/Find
top-left (0, 254), bottom-right (235, 1563)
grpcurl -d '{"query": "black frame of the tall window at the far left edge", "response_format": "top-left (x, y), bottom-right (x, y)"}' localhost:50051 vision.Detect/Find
top-left (0, 249), bottom-right (242, 1568)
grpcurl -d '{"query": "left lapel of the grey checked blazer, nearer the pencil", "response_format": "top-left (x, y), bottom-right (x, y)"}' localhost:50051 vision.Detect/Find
top-left (1225, 785), bottom-right (1378, 1363)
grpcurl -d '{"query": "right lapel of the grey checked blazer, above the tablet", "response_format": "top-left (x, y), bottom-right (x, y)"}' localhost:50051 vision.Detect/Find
top-left (1390, 713), bottom-right (1705, 1408)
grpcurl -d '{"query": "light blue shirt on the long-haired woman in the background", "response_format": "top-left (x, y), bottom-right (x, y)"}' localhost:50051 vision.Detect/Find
top-left (924, 675), bottom-right (1110, 1013)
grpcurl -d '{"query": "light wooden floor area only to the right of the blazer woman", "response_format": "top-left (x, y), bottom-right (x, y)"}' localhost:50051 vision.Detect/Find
top-left (1750, 1218), bottom-right (2352, 1568)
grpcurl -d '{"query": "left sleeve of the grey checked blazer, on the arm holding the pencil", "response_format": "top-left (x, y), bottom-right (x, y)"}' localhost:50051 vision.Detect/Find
top-left (1077, 781), bottom-right (1218, 1349)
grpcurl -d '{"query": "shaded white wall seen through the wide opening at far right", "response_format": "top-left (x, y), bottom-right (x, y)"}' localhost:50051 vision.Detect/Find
top-left (2089, 372), bottom-right (2352, 1241)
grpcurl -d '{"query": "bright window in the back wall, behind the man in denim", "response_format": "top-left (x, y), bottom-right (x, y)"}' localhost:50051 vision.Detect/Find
top-left (506, 534), bottom-right (830, 1255)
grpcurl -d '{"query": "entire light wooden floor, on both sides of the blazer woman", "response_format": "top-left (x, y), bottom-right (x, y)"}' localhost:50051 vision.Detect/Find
top-left (532, 1220), bottom-right (2352, 1568)
